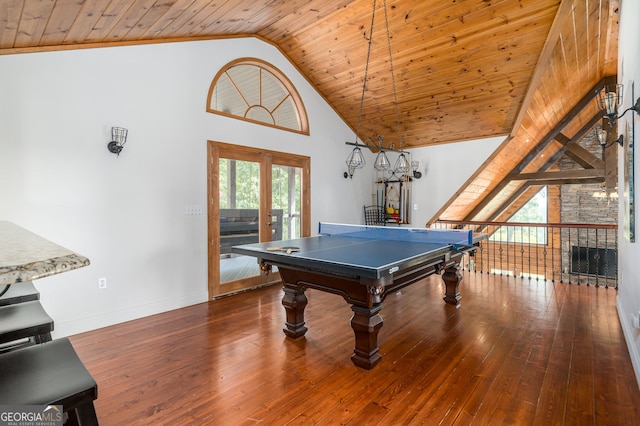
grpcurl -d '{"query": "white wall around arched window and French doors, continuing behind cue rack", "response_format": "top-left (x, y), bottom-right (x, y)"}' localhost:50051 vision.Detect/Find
top-left (0, 38), bottom-right (494, 336)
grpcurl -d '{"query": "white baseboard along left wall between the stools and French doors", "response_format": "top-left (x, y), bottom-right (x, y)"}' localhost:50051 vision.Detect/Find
top-left (51, 292), bottom-right (207, 338)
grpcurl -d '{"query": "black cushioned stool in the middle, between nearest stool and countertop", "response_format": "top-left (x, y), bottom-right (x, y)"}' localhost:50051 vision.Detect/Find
top-left (0, 301), bottom-right (53, 350)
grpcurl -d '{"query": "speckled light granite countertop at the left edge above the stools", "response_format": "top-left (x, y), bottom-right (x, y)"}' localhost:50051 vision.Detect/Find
top-left (0, 221), bottom-right (89, 285)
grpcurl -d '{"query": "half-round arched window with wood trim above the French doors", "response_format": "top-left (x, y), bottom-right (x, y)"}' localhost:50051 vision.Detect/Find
top-left (207, 58), bottom-right (309, 135)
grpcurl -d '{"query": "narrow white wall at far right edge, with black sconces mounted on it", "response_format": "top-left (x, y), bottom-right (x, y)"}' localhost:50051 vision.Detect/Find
top-left (617, 0), bottom-right (640, 386)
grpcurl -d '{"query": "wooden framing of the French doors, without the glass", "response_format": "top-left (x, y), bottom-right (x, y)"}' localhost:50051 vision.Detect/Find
top-left (207, 140), bottom-right (311, 300)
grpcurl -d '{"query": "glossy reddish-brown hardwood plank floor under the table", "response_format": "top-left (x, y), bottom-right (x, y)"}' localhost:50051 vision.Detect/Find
top-left (71, 272), bottom-right (640, 425)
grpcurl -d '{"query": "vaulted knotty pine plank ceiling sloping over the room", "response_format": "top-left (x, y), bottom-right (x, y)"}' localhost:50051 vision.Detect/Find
top-left (0, 0), bottom-right (618, 223)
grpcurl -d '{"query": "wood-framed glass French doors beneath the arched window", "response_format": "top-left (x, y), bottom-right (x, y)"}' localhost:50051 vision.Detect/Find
top-left (208, 141), bottom-right (311, 299)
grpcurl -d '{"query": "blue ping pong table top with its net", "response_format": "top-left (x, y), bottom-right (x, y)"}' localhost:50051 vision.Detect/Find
top-left (232, 222), bottom-right (474, 279)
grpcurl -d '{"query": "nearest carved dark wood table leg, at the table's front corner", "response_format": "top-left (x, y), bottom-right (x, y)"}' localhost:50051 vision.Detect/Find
top-left (351, 304), bottom-right (382, 370)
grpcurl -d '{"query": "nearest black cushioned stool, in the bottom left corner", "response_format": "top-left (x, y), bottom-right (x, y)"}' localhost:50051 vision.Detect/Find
top-left (0, 338), bottom-right (98, 425)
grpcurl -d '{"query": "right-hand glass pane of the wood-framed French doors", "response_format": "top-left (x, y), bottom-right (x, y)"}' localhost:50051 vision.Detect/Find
top-left (271, 164), bottom-right (302, 241)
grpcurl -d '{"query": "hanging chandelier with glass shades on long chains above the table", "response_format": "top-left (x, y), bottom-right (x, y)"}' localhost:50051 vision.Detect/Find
top-left (344, 0), bottom-right (411, 178)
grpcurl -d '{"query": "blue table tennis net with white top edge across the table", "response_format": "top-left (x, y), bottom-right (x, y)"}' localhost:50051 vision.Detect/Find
top-left (318, 222), bottom-right (473, 244)
